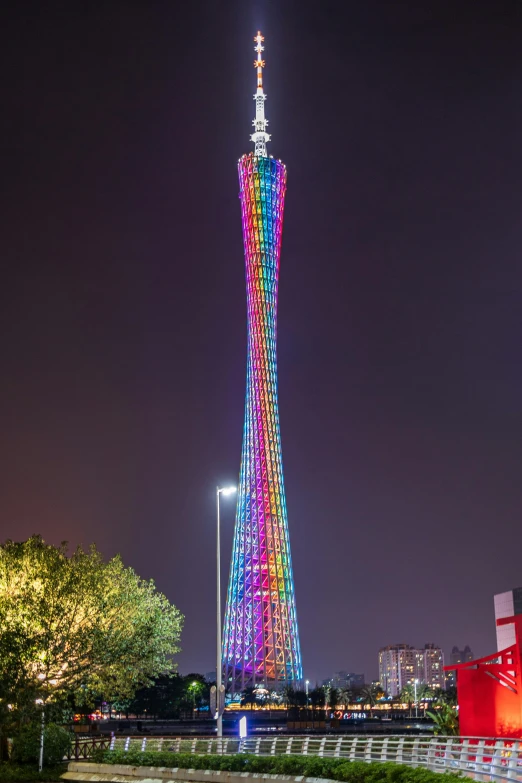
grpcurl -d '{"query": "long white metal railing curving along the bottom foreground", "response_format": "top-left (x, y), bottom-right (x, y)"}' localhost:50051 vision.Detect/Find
top-left (104, 735), bottom-right (522, 783)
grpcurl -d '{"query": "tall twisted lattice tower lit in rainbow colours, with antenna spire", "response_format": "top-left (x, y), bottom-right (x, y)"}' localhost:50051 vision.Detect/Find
top-left (222, 32), bottom-right (302, 693)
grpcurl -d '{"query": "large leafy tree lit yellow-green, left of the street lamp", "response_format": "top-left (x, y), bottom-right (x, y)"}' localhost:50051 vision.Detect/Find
top-left (0, 536), bottom-right (183, 708)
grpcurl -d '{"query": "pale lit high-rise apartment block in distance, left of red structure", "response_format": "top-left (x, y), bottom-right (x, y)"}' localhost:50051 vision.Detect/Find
top-left (379, 643), bottom-right (446, 696)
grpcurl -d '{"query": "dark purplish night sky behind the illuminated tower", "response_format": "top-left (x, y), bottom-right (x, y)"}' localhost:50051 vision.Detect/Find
top-left (0, 0), bottom-right (522, 681)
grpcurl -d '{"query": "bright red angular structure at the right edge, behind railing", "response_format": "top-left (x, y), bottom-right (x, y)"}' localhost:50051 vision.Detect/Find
top-left (444, 615), bottom-right (522, 738)
